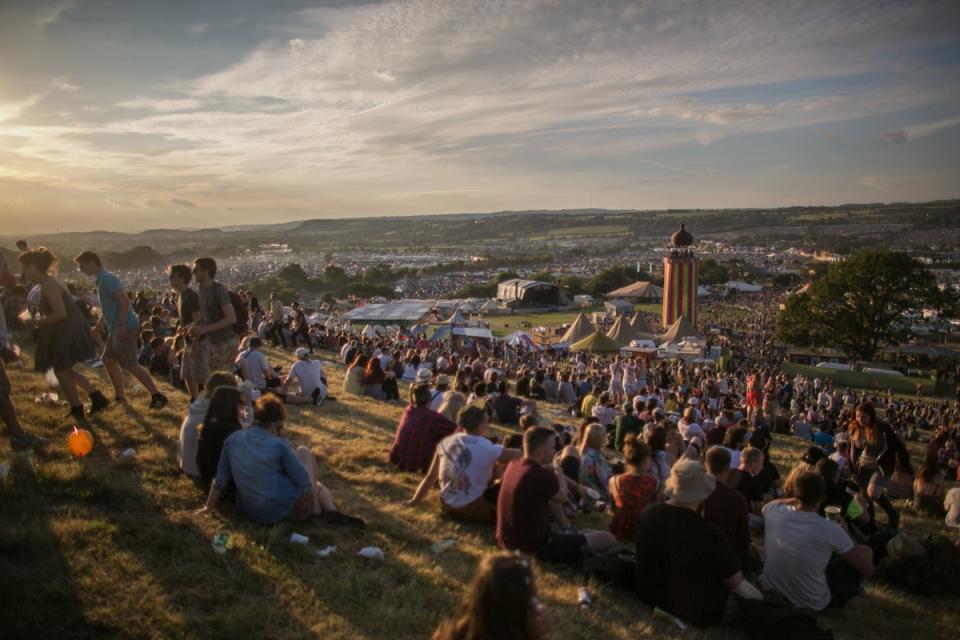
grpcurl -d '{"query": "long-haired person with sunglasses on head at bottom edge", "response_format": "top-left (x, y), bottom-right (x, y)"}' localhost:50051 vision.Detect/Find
top-left (432, 553), bottom-right (547, 640)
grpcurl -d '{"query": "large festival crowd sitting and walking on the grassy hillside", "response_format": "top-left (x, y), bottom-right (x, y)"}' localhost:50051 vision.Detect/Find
top-left (0, 247), bottom-right (960, 638)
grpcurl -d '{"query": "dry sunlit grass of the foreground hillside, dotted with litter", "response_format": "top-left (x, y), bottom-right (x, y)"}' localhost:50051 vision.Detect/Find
top-left (0, 344), bottom-right (960, 640)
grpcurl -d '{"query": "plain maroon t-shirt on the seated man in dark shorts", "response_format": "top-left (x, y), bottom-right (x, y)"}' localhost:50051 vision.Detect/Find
top-left (497, 458), bottom-right (560, 554)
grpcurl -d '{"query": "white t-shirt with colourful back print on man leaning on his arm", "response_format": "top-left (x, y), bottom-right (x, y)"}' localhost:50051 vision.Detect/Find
top-left (437, 433), bottom-right (503, 509)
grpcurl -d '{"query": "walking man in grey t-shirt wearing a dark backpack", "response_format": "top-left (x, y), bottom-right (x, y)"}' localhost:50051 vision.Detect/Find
top-left (187, 258), bottom-right (239, 371)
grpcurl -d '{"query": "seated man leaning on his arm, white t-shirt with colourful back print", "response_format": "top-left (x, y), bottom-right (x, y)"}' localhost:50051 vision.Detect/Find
top-left (409, 407), bottom-right (521, 524)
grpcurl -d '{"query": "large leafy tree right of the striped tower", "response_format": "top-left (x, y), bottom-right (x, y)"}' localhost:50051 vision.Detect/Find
top-left (777, 250), bottom-right (956, 360)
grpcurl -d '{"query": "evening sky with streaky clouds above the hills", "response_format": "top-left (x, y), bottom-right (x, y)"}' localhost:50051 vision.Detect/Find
top-left (0, 0), bottom-right (960, 235)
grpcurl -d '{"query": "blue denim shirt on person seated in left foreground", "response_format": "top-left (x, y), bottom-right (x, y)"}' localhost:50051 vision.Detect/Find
top-left (214, 425), bottom-right (312, 524)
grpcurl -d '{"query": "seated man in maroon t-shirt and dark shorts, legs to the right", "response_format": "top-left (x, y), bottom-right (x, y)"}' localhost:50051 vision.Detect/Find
top-left (497, 427), bottom-right (616, 564)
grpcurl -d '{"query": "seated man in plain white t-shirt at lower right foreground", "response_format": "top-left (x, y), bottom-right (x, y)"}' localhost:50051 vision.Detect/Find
top-left (760, 471), bottom-right (874, 611)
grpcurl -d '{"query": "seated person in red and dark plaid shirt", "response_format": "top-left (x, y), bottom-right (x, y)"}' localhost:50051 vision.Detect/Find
top-left (390, 385), bottom-right (457, 473)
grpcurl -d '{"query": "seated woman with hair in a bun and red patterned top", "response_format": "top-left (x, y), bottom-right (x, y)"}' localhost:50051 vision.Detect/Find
top-left (609, 433), bottom-right (657, 542)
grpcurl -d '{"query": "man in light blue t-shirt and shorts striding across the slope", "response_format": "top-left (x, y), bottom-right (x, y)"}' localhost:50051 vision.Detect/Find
top-left (71, 251), bottom-right (167, 409)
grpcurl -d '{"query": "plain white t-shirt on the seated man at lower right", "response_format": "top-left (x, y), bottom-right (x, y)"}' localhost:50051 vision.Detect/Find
top-left (760, 502), bottom-right (853, 611)
